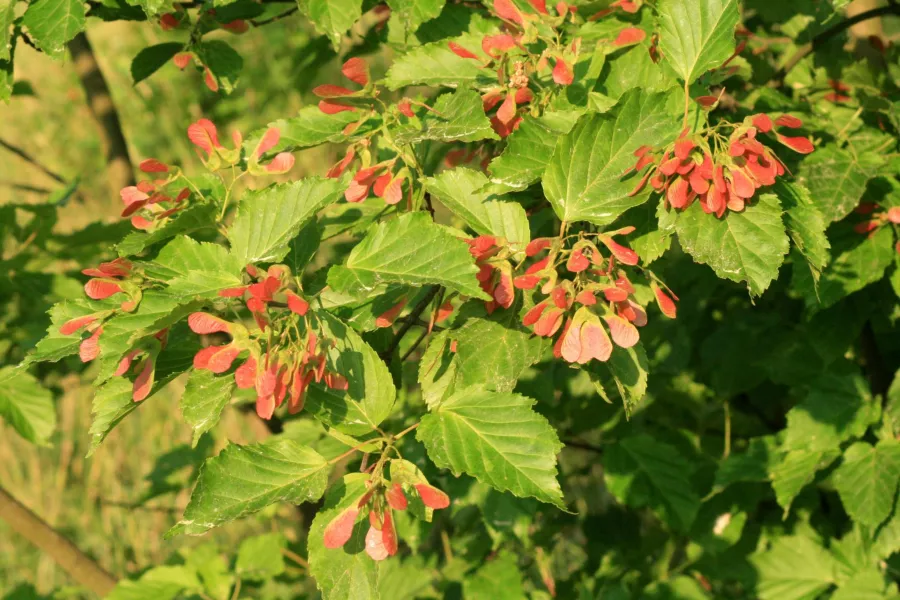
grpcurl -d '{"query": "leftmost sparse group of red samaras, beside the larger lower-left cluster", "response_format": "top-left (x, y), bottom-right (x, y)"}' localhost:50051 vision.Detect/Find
top-left (59, 258), bottom-right (168, 402)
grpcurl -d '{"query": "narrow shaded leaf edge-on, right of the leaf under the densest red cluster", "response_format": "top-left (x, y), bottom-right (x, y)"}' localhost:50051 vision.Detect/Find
top-left (772, 179), bottom-right (831, 276)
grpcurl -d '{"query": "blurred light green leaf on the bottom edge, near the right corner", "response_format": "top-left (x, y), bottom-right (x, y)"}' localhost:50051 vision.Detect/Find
top-left (751, 535), bottom-right (836, 600)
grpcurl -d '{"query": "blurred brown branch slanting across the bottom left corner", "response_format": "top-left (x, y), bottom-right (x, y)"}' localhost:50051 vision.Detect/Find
top-left (0, 487), bottom-right (116, 597)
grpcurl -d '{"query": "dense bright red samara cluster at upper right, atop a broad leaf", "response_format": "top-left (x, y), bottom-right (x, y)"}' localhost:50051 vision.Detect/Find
top-left (623, 114), bottom-right (814, 218)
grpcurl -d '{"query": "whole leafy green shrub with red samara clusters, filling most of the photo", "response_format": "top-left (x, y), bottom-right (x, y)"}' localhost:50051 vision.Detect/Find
top-left (0, 0), bottom-right (900, 600)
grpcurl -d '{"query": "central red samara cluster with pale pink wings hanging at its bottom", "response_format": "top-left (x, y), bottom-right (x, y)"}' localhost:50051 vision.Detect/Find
top-left (467, 227), bottom-right (677, 364)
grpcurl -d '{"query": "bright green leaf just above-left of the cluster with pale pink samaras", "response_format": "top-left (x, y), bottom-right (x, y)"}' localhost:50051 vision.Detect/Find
top-left (425, 167), bottom-right (531, 249)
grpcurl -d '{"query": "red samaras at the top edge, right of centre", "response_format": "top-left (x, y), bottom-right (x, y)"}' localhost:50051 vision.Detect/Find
top-left (448, 0), bottom-right (646, 138)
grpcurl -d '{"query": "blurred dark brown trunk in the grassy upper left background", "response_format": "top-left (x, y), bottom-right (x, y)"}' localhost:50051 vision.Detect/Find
top-left (69, 32), bottom-right (134, 193)
